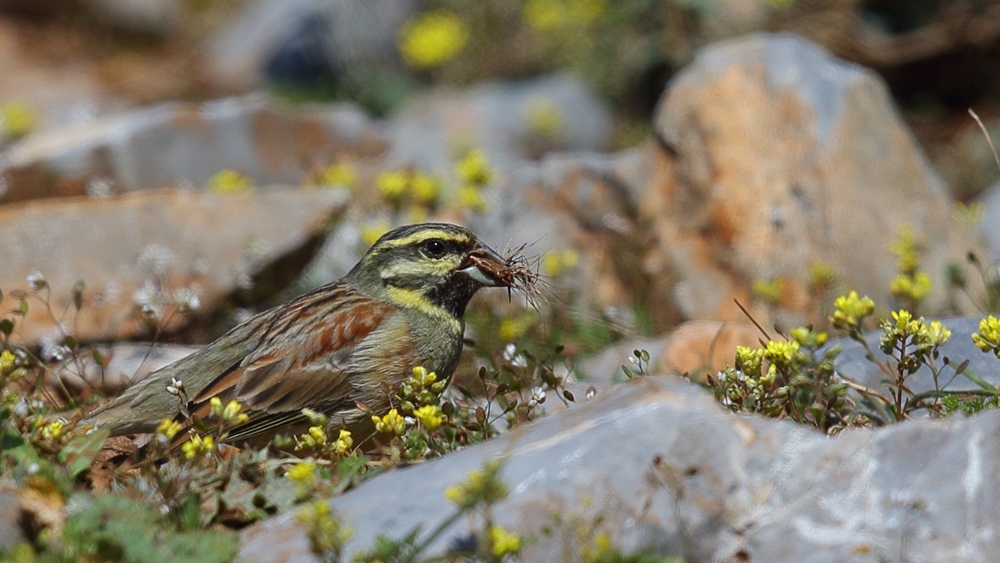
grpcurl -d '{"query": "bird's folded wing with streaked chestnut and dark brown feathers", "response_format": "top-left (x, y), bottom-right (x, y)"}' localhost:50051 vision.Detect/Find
top-left (190, 284), bottom-right (397, 440)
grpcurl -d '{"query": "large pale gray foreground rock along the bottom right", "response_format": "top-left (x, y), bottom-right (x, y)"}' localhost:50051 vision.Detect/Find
top-left (241, 377), bottom-right (1000, 562)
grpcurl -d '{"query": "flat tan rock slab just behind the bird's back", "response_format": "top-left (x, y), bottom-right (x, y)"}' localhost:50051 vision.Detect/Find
top-left (0, 189), bottom-right (347, 346)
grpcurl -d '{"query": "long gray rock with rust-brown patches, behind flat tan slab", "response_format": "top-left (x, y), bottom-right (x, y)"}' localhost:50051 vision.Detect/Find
top-left (0, 95), bottom-right (385, 201)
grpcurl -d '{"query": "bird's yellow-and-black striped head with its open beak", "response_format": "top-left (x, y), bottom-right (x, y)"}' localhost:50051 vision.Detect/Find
top-left (347, 223), bottom-right (510, 319)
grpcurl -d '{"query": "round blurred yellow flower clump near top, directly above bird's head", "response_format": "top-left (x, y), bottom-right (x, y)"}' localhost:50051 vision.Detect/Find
top-left (398, 10), bottom-right (469, 69)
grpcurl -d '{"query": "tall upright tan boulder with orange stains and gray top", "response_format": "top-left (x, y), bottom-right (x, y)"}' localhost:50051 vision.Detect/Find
top-left (639, 35), bottom-right (975, 324)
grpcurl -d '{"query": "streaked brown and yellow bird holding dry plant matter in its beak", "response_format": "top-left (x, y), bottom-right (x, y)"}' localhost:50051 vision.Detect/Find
top-left (81, 223), bottom-right (523, 443)
